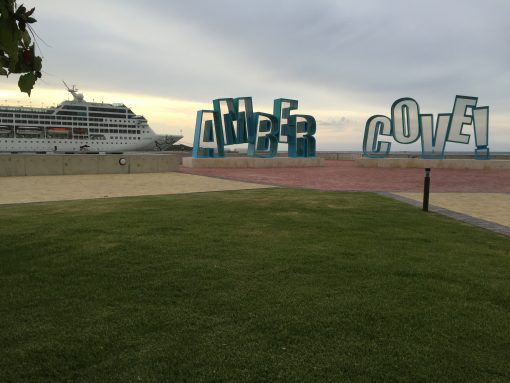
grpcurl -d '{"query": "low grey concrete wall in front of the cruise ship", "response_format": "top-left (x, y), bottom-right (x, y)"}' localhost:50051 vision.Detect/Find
top-left (0, 153), bottom-right (180, 177)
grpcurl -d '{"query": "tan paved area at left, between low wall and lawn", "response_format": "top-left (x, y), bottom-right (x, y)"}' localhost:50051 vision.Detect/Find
top-left (0, 173), bottom-right (270, 204)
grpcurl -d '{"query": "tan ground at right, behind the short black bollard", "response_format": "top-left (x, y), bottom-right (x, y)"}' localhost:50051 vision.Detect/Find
top-left (393, 193), bottom-right (510, 227)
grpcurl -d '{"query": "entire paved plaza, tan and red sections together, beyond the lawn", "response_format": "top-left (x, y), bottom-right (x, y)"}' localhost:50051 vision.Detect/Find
top-left (0, 161), bottom-right (510, 236)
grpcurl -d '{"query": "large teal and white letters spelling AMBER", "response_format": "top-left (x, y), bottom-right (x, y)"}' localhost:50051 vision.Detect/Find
top-left (192, 97), bottom-right (316, 158)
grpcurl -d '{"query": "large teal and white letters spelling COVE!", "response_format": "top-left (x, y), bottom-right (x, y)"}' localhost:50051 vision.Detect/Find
top-left (363, 96), bottom-right (490, 160)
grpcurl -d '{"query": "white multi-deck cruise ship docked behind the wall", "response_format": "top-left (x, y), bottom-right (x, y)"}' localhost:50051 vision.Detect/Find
top-left (0, 83), bottom-right (182, 153)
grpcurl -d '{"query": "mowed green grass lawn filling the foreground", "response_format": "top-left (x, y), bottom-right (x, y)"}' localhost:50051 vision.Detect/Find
top-left (0, 189), bottom-right (510, 382)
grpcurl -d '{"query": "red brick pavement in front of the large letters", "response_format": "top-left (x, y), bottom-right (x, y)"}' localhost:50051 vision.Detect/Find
top-left (180, 161), bottom-right (510, 193)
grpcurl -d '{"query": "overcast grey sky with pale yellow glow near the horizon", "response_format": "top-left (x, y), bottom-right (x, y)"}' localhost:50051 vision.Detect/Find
top-left (0, 0), bottom-right (510, 151)
